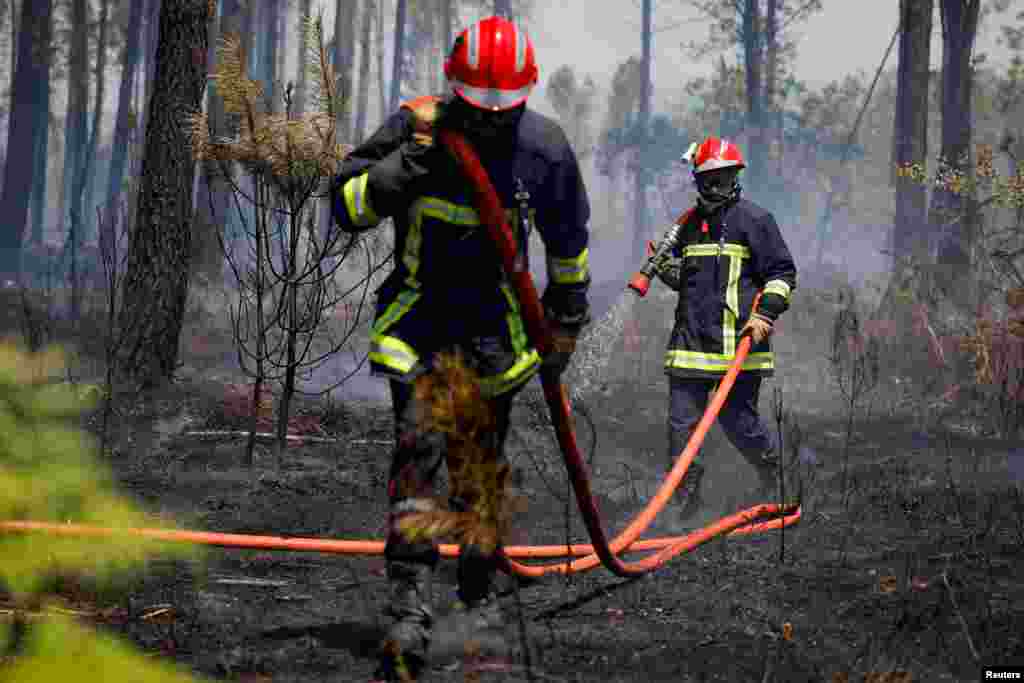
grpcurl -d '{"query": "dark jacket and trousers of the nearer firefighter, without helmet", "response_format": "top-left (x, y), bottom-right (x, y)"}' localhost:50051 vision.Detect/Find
top-left (332, 93), bottom-right (590, 651)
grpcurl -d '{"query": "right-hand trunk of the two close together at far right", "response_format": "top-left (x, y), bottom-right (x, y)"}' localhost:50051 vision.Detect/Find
top-left (932, 0), bottom-right (981, 293)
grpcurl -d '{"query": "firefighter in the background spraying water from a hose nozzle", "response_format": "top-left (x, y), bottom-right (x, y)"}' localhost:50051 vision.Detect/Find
top-left (648, 137), bottom-right (797, 519)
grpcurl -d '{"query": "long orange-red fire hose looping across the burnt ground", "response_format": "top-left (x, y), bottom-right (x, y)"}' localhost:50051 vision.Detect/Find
top-left (0, 131), bottom-right (801, 578)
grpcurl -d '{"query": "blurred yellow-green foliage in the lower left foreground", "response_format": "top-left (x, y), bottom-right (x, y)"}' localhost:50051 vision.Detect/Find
top-left (0, 343), bottom-right (205, 682)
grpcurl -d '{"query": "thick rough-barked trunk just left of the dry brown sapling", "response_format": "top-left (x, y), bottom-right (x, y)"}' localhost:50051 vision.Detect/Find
top-left (119, 0), bottom-right (210, 386)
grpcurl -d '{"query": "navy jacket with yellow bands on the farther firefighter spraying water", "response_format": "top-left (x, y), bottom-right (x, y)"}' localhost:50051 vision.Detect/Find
top-left (658, 199), bottom-right (797, 379)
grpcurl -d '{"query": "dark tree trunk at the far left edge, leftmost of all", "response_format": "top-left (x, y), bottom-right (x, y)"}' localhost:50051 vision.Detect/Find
top-left (0, 0), bottom-right (53, 284)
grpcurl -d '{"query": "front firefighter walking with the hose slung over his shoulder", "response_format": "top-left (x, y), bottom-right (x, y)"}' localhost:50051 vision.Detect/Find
top-left (332, 16), bottom-right (591, 679)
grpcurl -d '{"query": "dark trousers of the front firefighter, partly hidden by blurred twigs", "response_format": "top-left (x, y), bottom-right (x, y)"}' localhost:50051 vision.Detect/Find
top-left (384, 380), bottom-right (517, 615)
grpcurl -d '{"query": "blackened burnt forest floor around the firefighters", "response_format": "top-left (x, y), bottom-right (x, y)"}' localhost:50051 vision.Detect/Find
top-left (6, 282), bottom-right (1024, 683)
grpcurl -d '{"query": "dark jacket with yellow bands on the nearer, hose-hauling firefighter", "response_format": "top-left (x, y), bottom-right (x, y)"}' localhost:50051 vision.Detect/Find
top-left (332, 97), bottom-right (590, 395)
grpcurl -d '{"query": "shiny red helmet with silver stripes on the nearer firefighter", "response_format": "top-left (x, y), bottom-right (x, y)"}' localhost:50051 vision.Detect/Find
top-left (444, 16), bottom-right (538, 111)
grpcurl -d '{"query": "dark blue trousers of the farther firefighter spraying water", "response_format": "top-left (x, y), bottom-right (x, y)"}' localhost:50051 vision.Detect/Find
top-left (667, 373), bottom-right (775, 471)
